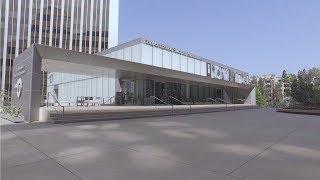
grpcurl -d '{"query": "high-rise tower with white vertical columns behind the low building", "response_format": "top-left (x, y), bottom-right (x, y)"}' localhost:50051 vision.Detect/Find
top-left (0, 0), bottom-right (119, 91)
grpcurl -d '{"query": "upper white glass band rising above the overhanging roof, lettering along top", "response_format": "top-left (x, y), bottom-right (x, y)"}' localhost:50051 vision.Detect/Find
top-left (101, 38), bottom-right (249, 84)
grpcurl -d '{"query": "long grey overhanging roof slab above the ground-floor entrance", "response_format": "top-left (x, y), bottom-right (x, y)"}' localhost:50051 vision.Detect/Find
top-left (35, 44), bottom-right (251, 89)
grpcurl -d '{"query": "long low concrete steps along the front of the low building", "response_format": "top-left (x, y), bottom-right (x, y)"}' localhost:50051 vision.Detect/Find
top-left (44, 104), bottom-right (257, 123)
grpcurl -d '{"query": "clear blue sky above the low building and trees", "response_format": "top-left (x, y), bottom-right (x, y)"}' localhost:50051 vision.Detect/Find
top-left (119, 0), bottom-right (320, 75)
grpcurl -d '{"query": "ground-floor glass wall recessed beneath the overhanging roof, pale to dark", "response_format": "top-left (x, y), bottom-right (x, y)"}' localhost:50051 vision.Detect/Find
top-left (43, 70), bottom-right (229, 106)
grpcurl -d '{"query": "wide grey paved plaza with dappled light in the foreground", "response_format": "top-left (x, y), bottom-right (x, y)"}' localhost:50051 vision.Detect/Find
top-left (1, 109), bottom-right (320, 180)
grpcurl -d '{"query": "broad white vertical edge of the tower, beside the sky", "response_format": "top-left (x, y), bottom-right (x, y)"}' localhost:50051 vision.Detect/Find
top-left (108, 0), bottom-right (119, 48)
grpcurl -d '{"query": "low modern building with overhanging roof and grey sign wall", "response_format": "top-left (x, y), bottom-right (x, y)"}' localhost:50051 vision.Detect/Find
top-left (12, 38), bottom-right (255, 121)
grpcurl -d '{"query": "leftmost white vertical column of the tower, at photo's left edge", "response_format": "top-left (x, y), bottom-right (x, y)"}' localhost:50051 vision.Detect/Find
top-left (1, 0), bottom-right (10, 91)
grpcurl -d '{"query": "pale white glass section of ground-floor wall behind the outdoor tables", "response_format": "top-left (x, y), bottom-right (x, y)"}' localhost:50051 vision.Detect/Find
top-left (47, 70), bottom-right (117, 106)
